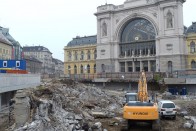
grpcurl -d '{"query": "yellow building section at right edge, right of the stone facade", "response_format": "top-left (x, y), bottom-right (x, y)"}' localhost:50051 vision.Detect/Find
top-left (186, 22), bottom-right (196, 69)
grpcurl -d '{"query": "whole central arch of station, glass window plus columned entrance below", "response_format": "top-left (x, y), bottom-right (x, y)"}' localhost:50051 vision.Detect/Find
top-left (119, 18), bottom-right (156, 72)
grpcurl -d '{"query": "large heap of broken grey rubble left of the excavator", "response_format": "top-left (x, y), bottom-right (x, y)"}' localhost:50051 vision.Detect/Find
top-left (12, 79), bottom-right (123, 131)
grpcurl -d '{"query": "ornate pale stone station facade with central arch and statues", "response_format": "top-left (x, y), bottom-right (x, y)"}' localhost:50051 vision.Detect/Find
top-left (95, 0), bottom-right (187, 72)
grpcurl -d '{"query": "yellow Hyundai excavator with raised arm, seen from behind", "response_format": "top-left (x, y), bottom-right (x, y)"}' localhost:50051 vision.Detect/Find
top-left (123, 71), bottom-right (160, 130)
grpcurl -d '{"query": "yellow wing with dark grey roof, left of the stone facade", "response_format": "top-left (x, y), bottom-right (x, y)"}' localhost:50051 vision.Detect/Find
top-left (64, 36), bottom-right (97, 74)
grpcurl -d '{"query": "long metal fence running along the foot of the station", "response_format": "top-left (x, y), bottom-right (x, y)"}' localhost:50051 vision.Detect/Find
top-left (61, 70), bottom-right (196, 81)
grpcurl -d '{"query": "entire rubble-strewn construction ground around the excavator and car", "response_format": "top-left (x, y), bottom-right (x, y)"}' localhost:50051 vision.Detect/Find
top-left (0, 71), bottom-right (196, 131)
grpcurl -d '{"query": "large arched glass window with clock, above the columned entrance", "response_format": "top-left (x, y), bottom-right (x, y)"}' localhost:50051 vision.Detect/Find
top-left (119, 18), bottom-right (156, 57)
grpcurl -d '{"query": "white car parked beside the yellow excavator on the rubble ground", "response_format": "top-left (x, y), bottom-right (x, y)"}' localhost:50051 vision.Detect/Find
top-left (158, 100), bottom-right (177, 120)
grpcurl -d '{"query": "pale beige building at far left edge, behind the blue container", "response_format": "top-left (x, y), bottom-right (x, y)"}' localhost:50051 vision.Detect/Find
top-left (0, 32), bottom-right (13, 60)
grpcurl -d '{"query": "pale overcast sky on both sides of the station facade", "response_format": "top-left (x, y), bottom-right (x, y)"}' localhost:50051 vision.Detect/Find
top-left (0, 0), bottom-right (196, 61)
